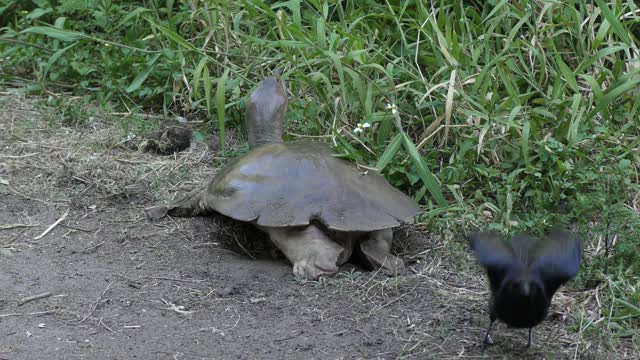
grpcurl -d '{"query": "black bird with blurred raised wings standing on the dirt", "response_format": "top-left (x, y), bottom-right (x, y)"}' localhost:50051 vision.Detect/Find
top-left (467, 230), bottom-right (582, 350)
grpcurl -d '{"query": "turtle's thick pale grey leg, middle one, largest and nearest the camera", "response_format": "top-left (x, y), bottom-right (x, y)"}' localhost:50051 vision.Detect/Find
top-left (260, 225), bottom-right (345, 280)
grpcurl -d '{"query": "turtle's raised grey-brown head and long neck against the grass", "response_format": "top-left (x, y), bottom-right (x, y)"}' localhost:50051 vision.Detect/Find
top-left (245, 74), bottom-right (288, 149)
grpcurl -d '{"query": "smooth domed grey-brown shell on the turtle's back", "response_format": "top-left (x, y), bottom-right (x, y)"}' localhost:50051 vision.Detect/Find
top-left (200, 142), bottom-right (419, 231)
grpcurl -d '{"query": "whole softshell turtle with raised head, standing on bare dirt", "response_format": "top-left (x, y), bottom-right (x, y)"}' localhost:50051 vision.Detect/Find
top-left (147, 76), bottom-right (419, 280)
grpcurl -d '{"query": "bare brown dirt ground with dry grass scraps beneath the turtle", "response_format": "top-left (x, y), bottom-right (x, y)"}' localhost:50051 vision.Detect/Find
top-left (0, 90), bottom-right (638, 359)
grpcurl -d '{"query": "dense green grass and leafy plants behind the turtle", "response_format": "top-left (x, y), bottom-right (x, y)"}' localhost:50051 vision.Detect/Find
top-left (0, 0), bottom-right (640, 344)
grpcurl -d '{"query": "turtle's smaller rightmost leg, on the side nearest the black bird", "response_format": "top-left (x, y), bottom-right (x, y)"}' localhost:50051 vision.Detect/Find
top-left (359, 229), bottom-right (404, 272)
